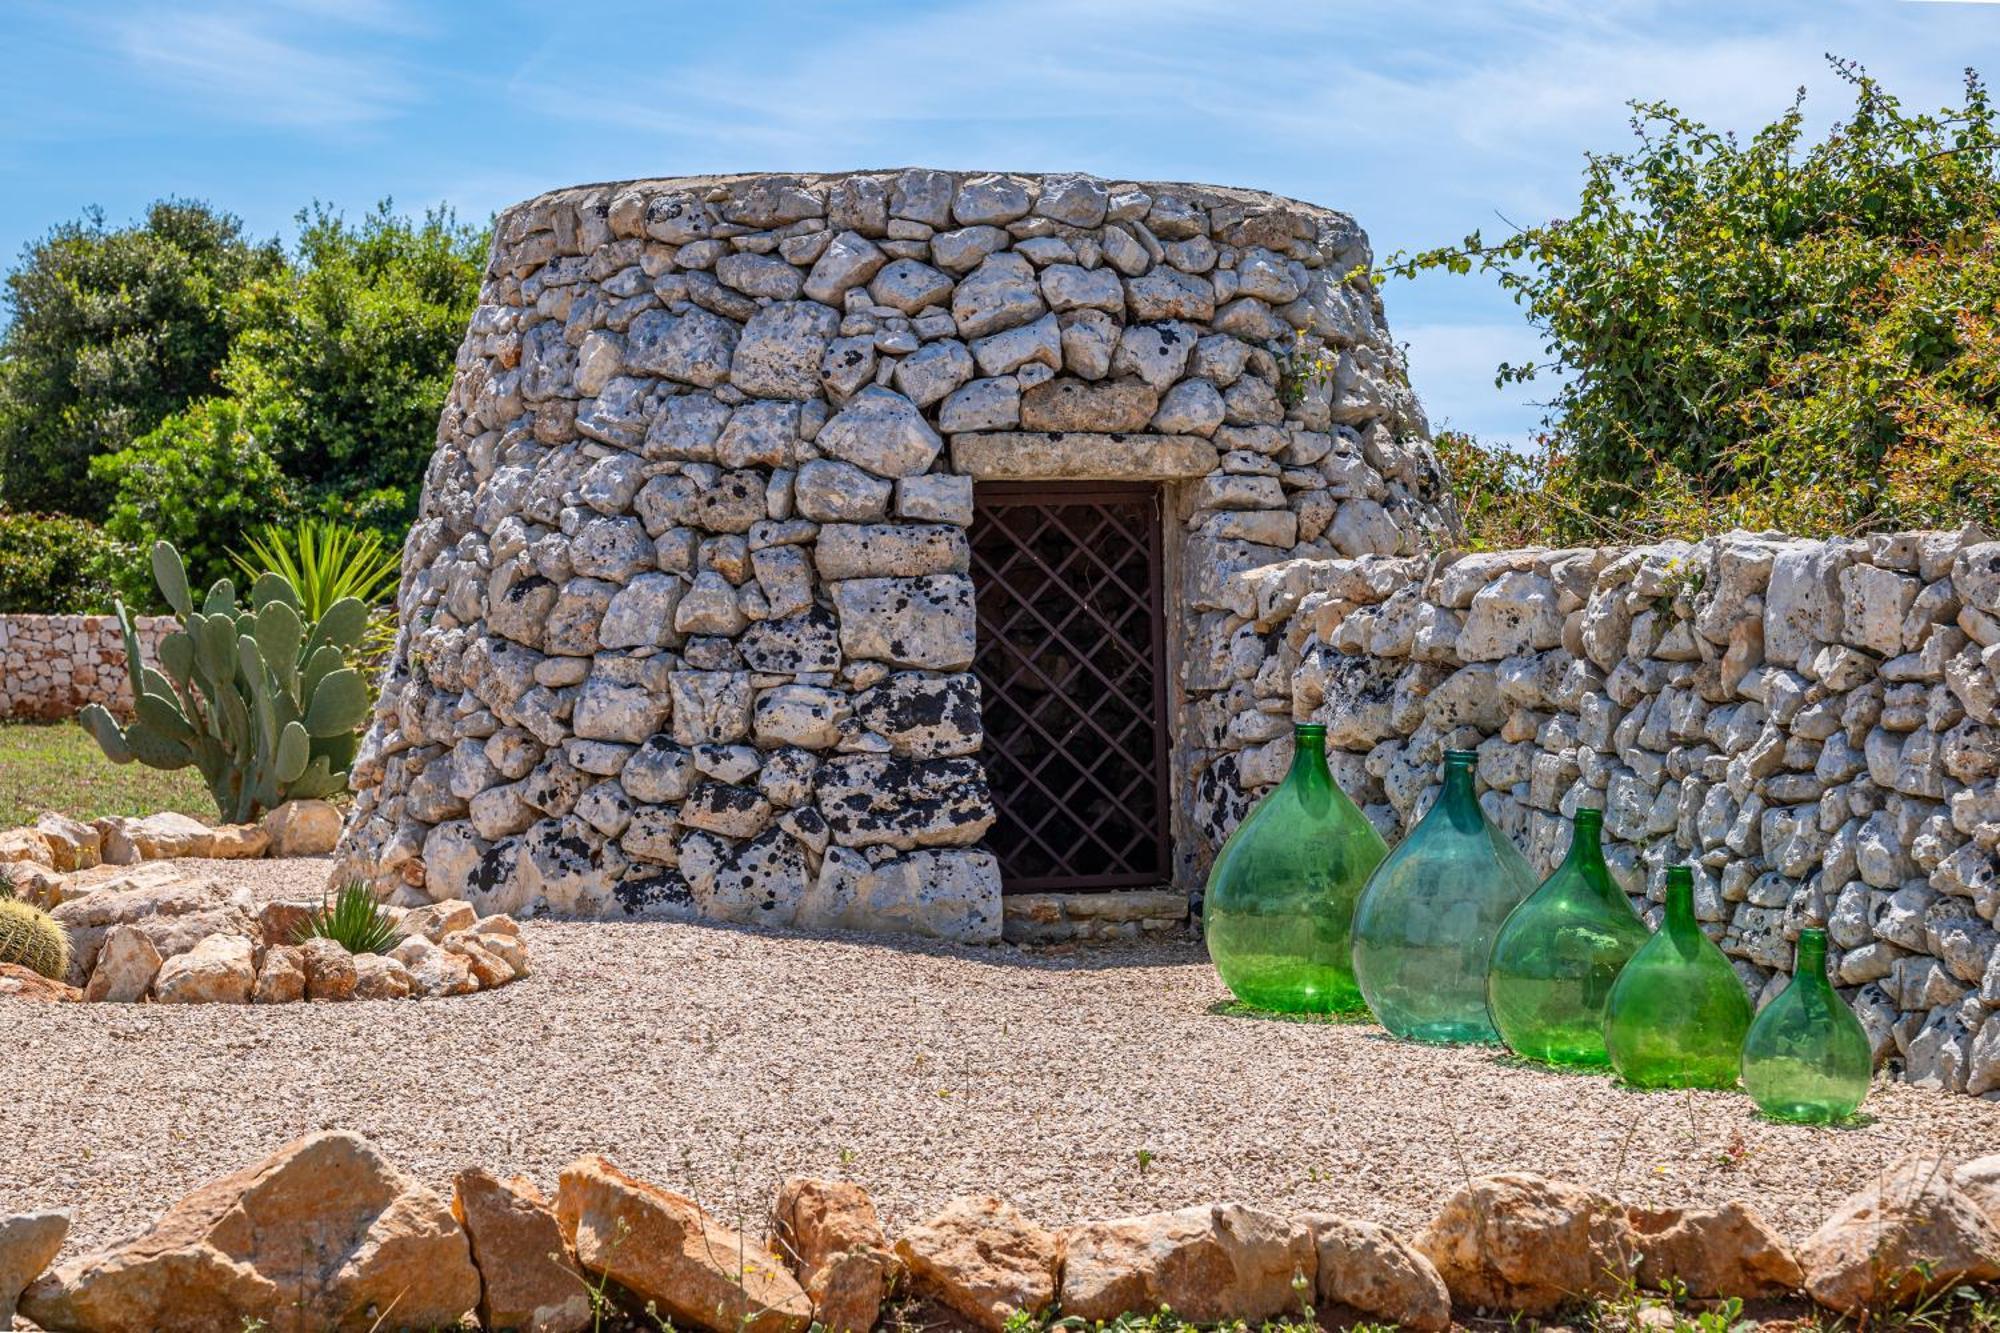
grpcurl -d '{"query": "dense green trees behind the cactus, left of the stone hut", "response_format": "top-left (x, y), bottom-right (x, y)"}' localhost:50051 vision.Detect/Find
top-left (0, 200), bottom-right (486, 610)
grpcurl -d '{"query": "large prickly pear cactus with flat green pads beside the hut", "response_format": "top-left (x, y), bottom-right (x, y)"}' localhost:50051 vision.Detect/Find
top-left (78, 542), bottom-right (370, 823)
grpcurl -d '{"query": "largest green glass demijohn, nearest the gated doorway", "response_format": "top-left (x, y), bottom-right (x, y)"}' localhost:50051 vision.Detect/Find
top-left (1202, 723), bottom-right (1388, 1013)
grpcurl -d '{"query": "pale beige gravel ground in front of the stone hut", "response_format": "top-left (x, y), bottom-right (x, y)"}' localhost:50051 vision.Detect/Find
top-left (0, 861), bottom-right (2000, 1253)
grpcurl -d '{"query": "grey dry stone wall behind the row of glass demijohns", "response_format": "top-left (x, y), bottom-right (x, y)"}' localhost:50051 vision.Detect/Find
top-left (1196, 530), bottom-right (2000, 1099)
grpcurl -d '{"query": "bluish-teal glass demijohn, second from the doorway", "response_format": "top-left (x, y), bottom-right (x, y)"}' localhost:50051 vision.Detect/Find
top-left (1354, 751), bottom-right (1534, 1043)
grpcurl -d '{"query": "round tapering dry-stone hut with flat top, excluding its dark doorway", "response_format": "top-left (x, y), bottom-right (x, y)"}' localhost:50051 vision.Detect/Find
top-left (336, 168), bottom-right (1454, 941)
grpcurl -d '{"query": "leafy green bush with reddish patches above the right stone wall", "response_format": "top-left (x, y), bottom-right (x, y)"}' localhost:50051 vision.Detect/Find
top-left (1388, 62), bottom-right (2000, 540)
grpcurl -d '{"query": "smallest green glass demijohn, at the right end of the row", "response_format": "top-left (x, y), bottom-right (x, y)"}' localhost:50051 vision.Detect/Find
top-left (1742, 929), bottom-right (1874, 1125)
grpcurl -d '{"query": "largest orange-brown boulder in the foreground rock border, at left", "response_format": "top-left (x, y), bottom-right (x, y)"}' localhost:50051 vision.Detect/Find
top-left (22, 1133), bottom-right (480, 1333)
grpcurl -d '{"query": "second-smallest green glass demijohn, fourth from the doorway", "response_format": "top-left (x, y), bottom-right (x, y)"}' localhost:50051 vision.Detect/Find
top-left (1604, 865), bottom-right (1750, 1087)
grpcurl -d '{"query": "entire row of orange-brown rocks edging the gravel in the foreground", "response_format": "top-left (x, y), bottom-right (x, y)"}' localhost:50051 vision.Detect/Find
top-left (0, 1131), bottom-right (2000, 1333)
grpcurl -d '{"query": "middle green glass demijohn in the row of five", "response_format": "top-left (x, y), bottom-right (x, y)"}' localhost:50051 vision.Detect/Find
top-left (1486, 807), bottom-right (1648, 1067)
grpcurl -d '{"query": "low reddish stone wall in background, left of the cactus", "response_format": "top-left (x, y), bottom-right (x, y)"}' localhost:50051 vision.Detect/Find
top-left (0, 616), bottom-right (174, 721)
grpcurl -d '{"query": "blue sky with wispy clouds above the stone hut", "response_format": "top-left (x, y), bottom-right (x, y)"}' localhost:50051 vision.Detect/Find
top-left (0, 0), bottom-right (2000, 438)
